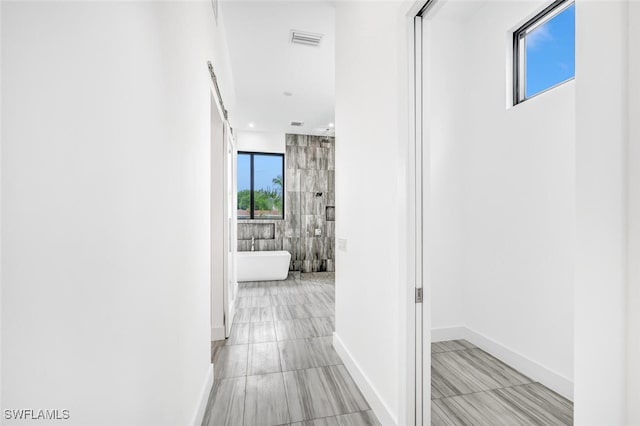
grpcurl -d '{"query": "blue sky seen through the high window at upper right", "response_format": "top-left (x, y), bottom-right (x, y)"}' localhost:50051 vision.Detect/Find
top-left (525, 4), bottom-right (576, 98)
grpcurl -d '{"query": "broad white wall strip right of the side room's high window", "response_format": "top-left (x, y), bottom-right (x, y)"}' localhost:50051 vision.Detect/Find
top-left (574, 0), bottom-right (627, 425)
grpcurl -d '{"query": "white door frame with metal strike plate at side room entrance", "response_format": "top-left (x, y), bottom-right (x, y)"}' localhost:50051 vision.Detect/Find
top-left (405, 0), bottom-right (437, 425)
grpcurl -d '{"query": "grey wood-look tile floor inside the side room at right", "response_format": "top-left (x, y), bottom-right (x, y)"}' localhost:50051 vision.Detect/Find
top-left (431, 340), bottom-right (573, 426)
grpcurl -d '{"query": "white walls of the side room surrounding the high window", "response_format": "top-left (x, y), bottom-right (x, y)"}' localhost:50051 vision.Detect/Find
top-left (425, 2), bottom-right (575, 396)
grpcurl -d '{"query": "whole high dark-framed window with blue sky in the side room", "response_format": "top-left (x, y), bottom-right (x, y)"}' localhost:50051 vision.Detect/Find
top-left (513, 0), bottom-right (576, 104)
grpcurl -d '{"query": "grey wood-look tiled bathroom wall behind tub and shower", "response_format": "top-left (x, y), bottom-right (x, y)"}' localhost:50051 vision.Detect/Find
top-left (238, 134), bottom-right (335, 272)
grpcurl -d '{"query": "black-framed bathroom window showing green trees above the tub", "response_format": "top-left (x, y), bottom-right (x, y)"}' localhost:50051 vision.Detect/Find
top-left (238, 152), bottom-right (284, 219)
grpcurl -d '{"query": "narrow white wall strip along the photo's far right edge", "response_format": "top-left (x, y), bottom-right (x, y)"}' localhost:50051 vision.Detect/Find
top-left (627, 2), bottom-right (640, 425)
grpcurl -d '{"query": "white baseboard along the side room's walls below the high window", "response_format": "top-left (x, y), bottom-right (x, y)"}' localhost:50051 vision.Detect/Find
top-left (431, 327), bottom-right (573, 401)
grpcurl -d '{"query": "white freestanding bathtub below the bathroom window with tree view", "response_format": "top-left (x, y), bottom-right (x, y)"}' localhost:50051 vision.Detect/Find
top-left (236, 250), bottom-right (291, 282)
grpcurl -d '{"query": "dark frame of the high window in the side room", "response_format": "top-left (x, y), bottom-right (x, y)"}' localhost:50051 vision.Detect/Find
top-left (512, 0), bottom-right (576, 106)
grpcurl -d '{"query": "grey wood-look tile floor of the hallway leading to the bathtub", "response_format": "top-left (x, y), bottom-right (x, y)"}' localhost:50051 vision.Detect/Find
top-left (202, 273), bottom-right (380, 426)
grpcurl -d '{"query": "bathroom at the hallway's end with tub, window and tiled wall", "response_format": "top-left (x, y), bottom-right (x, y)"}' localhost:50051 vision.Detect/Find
top-left (237, 132), bottom-right (335, 282)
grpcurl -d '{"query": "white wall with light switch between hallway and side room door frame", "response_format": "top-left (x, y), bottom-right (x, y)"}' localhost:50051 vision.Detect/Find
top-left (334, 2), bottom-right (408, 425)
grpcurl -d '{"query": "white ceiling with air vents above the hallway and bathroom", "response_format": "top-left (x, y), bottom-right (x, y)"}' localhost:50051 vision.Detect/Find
top-left (220, 0), bottom-right (335, 134)
